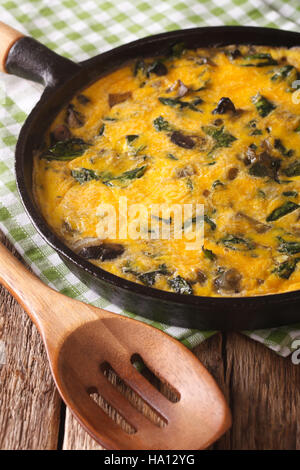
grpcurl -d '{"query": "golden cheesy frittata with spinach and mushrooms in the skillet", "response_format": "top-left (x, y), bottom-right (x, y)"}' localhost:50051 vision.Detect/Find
top-left (33, 46), bottom-right (300, 296)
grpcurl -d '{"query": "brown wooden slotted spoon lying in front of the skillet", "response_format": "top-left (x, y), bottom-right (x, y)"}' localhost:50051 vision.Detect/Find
top-left (0, 244), bottom-right (231, 450)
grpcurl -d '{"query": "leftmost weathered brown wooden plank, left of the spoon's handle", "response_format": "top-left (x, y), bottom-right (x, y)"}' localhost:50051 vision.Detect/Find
top-left (0, 234), bottom-right (61, 450)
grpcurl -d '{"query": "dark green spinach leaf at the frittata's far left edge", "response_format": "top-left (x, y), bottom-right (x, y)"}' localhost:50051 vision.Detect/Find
top-left (41, 137), bottom-right (90, 161)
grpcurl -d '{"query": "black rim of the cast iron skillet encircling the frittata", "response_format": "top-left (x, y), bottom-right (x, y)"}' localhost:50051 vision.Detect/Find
top-left (15, 26), bottom-right (300, 315)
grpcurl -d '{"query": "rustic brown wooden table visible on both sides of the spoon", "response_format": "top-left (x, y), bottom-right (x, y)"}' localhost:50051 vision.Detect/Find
top-left (0, 234), bottom-right (300, 450)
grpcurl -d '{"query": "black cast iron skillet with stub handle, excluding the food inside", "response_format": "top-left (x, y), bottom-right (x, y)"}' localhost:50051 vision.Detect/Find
top-left (2, 26), bottom-right (300, 330)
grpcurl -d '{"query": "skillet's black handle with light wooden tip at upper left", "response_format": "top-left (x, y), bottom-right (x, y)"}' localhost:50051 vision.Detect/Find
top-left (0, 21), bottom-right (81, 87)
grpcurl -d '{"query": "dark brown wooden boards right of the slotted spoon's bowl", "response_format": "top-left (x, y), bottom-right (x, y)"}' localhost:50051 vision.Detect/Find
top-left (196, 333), bottom-right (300, 450)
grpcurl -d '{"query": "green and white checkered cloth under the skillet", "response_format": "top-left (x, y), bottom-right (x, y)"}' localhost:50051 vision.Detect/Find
top-left (0, 0), bottom-right (300, 356)
